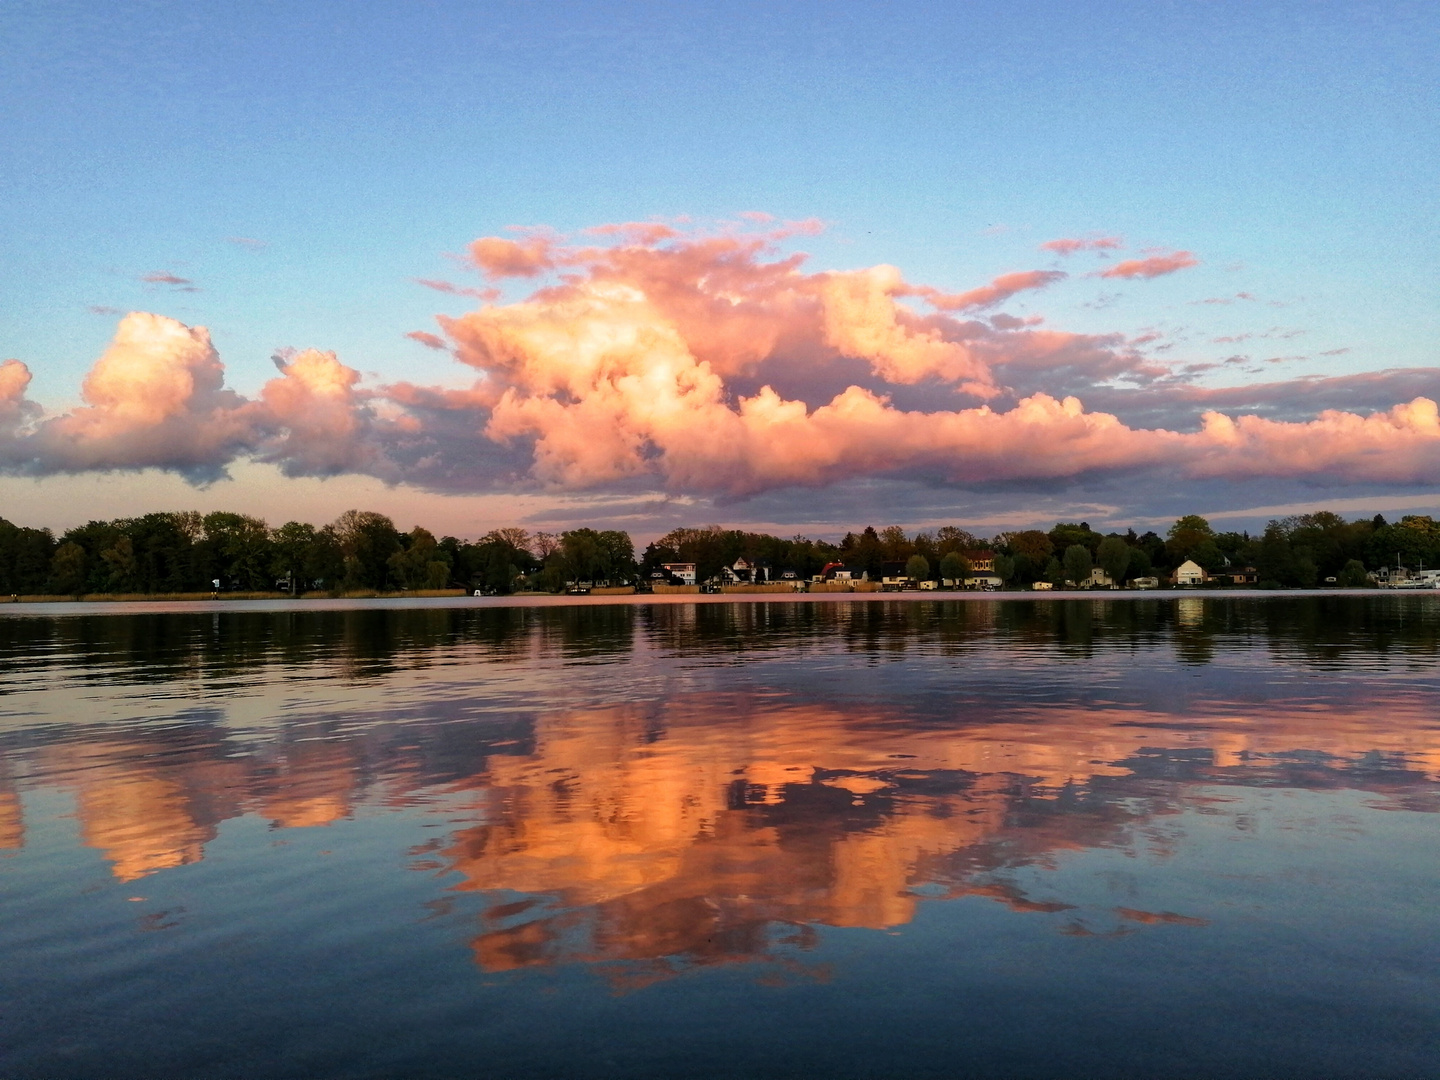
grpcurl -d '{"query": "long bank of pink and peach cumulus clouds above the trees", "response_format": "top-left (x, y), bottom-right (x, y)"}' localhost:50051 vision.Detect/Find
top-left (0, 223), bottom-right (1440, 498)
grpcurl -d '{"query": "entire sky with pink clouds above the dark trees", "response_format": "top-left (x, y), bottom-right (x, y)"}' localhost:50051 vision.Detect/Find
top-left (0, 0), bottom-right (1440, 540)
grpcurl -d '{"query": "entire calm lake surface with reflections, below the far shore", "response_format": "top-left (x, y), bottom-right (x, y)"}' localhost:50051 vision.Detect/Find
top-left (0, 595), bottom-right (1440, 1077)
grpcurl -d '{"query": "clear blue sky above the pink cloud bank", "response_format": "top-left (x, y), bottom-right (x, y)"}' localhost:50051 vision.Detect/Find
top-left (0, 0), bottom-right (1440, 538)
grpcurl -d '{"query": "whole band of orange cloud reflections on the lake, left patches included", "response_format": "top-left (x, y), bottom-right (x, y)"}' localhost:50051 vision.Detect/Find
top-left (14, 690), bottom-right (1440, 971)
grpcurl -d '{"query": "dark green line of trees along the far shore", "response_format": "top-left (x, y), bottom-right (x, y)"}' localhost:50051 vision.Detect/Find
top-left (0, 510), bottom-right (1440, 595)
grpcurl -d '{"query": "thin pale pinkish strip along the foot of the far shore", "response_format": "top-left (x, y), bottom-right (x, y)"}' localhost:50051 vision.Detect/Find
top-left (0, 589), bottom-right (1416, 618)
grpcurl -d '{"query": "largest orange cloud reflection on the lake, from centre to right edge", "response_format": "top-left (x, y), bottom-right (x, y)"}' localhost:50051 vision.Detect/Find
top-left (429, 696), bottom-right (1440, 971)
